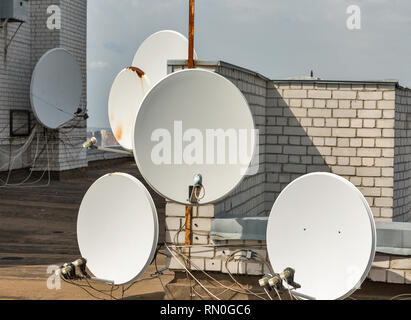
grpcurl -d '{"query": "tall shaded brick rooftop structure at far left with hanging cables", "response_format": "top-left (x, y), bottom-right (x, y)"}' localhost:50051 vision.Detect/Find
top-left (0, 0), bottom-right (87, 172)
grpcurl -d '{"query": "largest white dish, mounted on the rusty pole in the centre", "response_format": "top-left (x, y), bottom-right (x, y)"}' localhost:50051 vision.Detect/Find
top-left (133, 69), bottom-right (257, 204)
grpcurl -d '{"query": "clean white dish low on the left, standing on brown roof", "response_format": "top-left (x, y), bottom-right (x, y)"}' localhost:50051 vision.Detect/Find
top-left (77, 173), bottom-right (158, 285)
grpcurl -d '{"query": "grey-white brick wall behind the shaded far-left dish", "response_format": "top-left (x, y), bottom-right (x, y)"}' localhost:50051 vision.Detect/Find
top-left (0, 0), bottom-right (87, 171)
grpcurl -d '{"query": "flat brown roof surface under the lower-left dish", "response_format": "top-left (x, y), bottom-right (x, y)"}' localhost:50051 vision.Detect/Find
top-left (0, 158), bottom-right (410, 300)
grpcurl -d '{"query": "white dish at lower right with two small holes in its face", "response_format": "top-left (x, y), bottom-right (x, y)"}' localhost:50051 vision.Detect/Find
top-left (267, 173), bottom-right (376, 300)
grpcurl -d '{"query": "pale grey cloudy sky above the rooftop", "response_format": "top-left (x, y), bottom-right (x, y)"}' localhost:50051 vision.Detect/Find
top-left (87, 0), bottom-right (411, 128)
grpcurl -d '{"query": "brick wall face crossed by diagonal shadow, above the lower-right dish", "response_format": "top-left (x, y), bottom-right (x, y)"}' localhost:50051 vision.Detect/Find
top-left (267, 81), bottom-right (396, 220)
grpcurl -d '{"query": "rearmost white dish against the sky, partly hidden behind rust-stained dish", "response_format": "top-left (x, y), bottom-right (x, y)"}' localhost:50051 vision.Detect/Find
top-left (133, 30), bottom-right (197, 86)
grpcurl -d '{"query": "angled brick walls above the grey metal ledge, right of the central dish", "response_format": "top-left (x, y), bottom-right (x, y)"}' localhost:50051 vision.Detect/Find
top-left (172, 63), bottom-right (410, 221)
